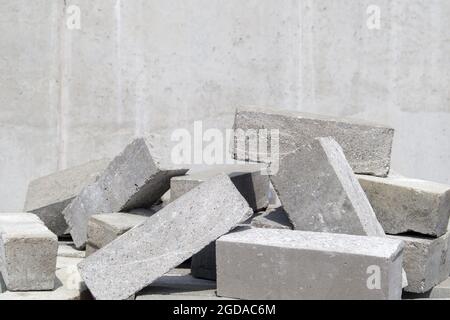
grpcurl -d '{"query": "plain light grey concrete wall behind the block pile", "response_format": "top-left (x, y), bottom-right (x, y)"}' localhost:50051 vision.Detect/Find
top-left (0, 0), bottom-right (450, 211)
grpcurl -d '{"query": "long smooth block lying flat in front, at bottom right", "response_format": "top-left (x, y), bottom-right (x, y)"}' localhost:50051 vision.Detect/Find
top-left (216, 228), bottom-right (402, 300)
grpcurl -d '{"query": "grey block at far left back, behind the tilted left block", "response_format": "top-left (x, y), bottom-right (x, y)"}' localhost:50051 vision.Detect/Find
top-left (24, 159), bottom-right (109, 236)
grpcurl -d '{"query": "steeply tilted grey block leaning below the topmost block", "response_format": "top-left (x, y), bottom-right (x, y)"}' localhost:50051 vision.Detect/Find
top-left (270, 138), bottom-right (384, 236)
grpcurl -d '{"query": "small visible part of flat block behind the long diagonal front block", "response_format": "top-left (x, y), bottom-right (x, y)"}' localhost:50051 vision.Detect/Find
top-left (86, 213), bottom-right (151, 256)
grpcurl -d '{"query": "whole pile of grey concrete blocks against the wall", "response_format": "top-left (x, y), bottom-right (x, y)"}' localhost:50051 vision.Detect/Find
top-left (0, 107), bottom-right (450, 300)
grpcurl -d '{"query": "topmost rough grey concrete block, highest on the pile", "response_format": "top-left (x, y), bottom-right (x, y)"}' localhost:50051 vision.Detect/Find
top-left (232, 107), bottom-right (394, 176)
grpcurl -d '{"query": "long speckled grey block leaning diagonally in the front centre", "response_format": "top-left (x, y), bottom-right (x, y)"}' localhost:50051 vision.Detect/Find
top-left (79, 174), bottom-right (253, 299)
